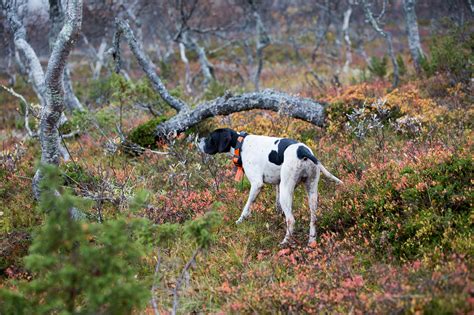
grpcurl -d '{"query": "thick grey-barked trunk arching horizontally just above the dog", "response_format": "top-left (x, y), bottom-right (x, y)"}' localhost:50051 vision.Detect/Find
top-left (156, 90), bottom-right (325, 137)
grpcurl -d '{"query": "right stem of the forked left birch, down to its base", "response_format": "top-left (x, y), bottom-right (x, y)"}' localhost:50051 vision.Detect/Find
top-left (33, 0), bottom-right (82, 197)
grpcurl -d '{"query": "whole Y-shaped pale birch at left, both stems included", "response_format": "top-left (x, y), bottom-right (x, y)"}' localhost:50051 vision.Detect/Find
top-left (2, 0), bottom-right (82, 197)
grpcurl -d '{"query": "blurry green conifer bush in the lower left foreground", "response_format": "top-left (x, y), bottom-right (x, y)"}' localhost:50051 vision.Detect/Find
top-left (0, 166), bottom-right (152, 314)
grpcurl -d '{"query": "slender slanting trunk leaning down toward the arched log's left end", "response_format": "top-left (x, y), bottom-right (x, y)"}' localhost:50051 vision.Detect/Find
top-left (113, 20), bottom-right (189, 112)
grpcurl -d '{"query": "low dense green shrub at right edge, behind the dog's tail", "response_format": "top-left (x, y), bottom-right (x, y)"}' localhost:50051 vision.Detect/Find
top-left (320, 156), bottom-right (474, 259)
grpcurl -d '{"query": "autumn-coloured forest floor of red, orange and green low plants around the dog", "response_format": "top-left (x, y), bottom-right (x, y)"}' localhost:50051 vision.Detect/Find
top-left (0, 43), bottom-right (474, 314)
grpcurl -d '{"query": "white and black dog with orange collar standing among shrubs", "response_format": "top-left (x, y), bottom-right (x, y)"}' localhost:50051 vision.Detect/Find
top-left (199, 128), bottom-right (342, 244)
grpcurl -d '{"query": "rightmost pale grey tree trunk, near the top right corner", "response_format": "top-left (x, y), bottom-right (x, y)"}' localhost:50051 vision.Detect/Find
top-left (403, 0), bottom-right (423, 73)
